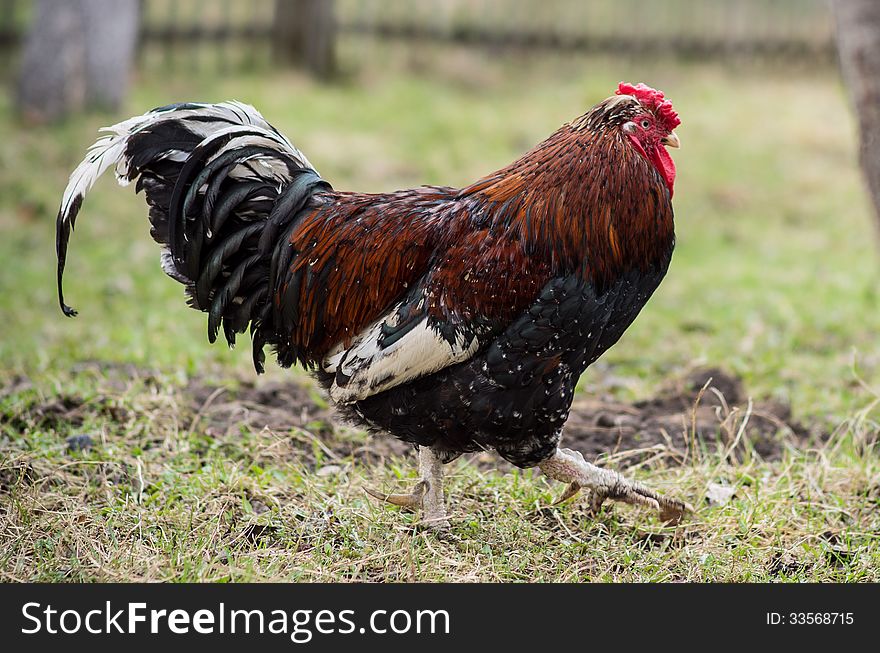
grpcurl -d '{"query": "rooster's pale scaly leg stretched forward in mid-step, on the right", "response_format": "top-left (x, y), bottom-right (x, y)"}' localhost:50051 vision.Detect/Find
top-left (540, 449), bottom-right (693, 524)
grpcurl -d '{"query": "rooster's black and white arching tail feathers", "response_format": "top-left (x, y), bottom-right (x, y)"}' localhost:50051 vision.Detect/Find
top-left (55, 101), bottom-right (331, 371)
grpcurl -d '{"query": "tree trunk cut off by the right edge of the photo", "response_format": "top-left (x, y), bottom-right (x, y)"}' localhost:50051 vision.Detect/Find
top-left (834, 0), bottom-right (880, 234)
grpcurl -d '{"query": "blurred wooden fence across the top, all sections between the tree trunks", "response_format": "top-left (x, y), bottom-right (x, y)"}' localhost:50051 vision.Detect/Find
top-left (0, 0), bottom-right (834, 76)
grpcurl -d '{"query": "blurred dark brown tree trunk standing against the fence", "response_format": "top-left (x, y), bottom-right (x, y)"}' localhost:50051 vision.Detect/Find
top-left (272, 0), bottom-right (336, 79)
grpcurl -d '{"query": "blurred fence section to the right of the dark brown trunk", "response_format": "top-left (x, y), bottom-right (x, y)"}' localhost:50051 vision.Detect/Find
top-left (337, 0), bottom-right (834, 58)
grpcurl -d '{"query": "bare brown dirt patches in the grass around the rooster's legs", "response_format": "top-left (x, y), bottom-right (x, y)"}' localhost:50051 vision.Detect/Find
top-left (0, 366), bottom-right (824, 468)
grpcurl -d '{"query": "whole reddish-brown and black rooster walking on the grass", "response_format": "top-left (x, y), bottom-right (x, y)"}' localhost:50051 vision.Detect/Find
top-left (56, 83), bottom-right (688, 526)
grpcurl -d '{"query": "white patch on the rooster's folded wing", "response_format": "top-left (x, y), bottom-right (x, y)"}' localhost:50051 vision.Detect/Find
top-left (323, 307), bottom-right (479, 404)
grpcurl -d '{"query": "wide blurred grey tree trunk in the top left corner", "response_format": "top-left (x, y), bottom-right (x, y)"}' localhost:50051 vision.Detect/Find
top-left (16, 0), bottom-right (140, 122)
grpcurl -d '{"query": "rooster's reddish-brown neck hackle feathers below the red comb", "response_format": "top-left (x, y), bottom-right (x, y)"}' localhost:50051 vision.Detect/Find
top-left (462, 96), bottom-right (674, 288)
